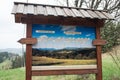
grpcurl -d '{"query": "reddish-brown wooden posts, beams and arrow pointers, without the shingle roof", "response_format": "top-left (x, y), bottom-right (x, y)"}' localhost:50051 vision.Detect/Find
top-left (19, 17), bottom-right (105, 80)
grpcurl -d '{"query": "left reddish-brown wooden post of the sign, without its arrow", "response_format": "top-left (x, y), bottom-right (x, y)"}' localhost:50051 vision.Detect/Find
top-left (26, 24), bottom-right (32, 80)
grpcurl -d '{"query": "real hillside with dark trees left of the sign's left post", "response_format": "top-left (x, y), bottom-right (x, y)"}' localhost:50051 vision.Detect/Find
top-left (0, 52), bottom-right (25, 69)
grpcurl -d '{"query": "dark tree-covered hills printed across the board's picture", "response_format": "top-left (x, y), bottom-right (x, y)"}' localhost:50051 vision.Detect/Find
top-left (32, 48), bottom-right (96, 59)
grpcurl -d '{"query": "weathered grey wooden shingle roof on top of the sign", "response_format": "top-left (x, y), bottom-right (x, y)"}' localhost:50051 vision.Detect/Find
top-left (12, 2), bottom-right (114, 19)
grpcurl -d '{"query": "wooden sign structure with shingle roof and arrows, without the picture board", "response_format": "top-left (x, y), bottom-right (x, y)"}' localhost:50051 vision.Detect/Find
top-left (12, 2), bottom-right (114, 80)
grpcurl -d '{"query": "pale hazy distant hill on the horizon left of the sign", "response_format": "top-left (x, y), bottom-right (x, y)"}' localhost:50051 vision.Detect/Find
top-left (0, 48), bottom-right (25, 55)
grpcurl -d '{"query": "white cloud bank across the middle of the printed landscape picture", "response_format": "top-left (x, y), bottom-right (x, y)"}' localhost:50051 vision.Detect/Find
top-left (33, 35), bottom-right (94, 49)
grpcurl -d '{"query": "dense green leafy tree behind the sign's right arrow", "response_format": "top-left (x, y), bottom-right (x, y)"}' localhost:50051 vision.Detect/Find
top-left (101, 21), bottom-right (120, 52)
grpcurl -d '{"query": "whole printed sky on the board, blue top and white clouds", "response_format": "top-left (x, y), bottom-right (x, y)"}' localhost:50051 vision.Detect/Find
top-left (32, 24), bottom-right (95, 49)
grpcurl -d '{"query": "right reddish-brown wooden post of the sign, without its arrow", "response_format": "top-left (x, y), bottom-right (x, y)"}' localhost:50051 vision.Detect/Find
top-left (96, 26), bottom-right (102, 80)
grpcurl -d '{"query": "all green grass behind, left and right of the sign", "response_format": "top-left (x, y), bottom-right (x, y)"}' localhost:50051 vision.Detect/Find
top-left (0, 56), bottom-right (120, 80)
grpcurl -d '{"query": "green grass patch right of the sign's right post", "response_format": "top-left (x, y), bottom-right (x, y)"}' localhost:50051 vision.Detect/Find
top-left (102, 56), bottom-right (120, 80)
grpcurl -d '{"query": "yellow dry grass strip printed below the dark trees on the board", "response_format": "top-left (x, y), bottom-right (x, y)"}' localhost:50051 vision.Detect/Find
top-left (32, 56), bottom-right (96, 65)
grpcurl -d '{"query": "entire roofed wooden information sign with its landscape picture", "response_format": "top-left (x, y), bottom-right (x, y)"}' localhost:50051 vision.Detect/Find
top-left (12, 2), bottom-right (113, 80)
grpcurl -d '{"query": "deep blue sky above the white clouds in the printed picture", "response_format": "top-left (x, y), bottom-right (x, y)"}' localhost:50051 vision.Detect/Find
top-left (32, 24), bottom-right (95, 39)
